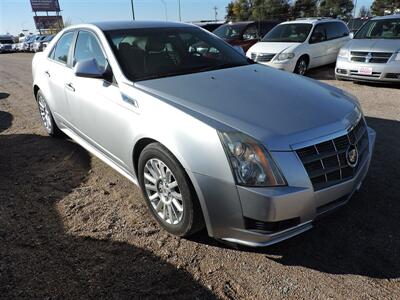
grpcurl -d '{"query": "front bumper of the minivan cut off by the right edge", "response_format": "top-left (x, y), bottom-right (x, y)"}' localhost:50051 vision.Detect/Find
top-left (335, 57), bottom-right (400, 83)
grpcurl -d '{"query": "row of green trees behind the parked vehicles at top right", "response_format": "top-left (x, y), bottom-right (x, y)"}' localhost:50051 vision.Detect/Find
top-left (226, 0), bottom-right (400, 21)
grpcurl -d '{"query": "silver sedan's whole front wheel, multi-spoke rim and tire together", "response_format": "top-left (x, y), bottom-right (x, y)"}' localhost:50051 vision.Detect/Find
top-left (138, 143), bottom-right (204, 237)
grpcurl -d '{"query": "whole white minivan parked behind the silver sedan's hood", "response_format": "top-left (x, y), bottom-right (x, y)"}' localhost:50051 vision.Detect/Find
top-left (247, 18), bottom-right (350, 75)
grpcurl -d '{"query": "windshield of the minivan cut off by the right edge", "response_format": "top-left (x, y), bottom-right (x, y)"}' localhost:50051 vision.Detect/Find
top-left (354, 18), bottom-right (400, 40)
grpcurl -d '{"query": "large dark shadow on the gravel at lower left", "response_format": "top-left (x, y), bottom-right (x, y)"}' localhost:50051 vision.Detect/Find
top-left (0, 131), bottom-right (214, 299)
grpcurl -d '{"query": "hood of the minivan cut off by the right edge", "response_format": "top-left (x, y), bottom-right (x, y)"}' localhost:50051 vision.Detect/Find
top-left (348, 39), bottom-right (400, 52)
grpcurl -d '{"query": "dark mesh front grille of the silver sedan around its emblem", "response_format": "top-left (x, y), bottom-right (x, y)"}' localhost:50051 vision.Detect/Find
top-left (296, 119), bottom-right (368, 191)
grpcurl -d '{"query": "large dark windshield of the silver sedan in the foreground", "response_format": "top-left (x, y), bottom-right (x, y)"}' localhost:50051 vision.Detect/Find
top-left (105, 27), bottom-right (253, 81)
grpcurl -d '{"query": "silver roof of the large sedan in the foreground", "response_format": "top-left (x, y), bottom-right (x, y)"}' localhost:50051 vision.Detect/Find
top-left (91, 21), bottom-right (195, 31)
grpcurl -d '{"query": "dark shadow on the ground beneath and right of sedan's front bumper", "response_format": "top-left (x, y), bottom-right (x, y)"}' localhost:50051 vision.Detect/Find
top-left (192, 117), bottom-right (400, 279)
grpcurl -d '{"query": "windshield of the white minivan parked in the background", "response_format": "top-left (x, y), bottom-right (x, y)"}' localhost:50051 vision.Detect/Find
top-left (262, 23), bottom-right (312, 43)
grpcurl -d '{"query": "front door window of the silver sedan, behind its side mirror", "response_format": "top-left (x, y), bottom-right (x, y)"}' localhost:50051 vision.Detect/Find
top-left (73, 31), bottom-right (107, 70)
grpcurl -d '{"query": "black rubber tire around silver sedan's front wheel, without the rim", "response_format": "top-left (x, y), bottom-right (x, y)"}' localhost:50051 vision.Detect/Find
top-left (138, 143), bottom-right (195, 236)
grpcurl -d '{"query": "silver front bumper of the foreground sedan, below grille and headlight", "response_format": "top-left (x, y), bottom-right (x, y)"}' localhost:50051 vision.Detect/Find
top-left (193, 128), bottom-right (376, 247)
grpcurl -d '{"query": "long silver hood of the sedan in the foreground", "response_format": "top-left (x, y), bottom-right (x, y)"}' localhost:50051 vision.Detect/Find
top-left (135, 64), bottom-right (358, 151)
